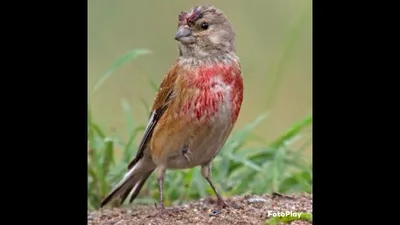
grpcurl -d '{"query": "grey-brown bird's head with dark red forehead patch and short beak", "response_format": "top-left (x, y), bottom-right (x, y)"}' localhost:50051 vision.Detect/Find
top-left (175, 5), bottom-right (235, 58)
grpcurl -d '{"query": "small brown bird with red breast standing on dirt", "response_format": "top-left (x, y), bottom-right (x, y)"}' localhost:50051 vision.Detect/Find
top-left (100, 5), bottom-right (243, 213)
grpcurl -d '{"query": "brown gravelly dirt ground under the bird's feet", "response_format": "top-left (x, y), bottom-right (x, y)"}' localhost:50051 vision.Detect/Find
top-left (88, 193), bottom-right (312, 225)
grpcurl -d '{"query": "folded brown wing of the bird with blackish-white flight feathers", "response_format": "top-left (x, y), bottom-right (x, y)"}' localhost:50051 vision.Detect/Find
top-left (128, 63), bottom-right (178, 169)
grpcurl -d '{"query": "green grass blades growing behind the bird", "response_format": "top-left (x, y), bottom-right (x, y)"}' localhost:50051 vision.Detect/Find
top-left (88, 50), bottom-right (312, 210)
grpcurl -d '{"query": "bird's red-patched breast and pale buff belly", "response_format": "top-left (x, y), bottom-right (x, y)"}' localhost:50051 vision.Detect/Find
top-left (167, 71), bottom-right (236, 168)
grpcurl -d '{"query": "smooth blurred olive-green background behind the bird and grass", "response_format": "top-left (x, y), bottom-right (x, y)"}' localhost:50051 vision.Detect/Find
top-left (88, 0), bottom-right (312, 209)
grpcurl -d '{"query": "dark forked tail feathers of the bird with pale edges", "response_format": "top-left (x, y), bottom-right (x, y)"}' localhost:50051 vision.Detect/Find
top-left (100, 158), bottom-right (155, 208)
